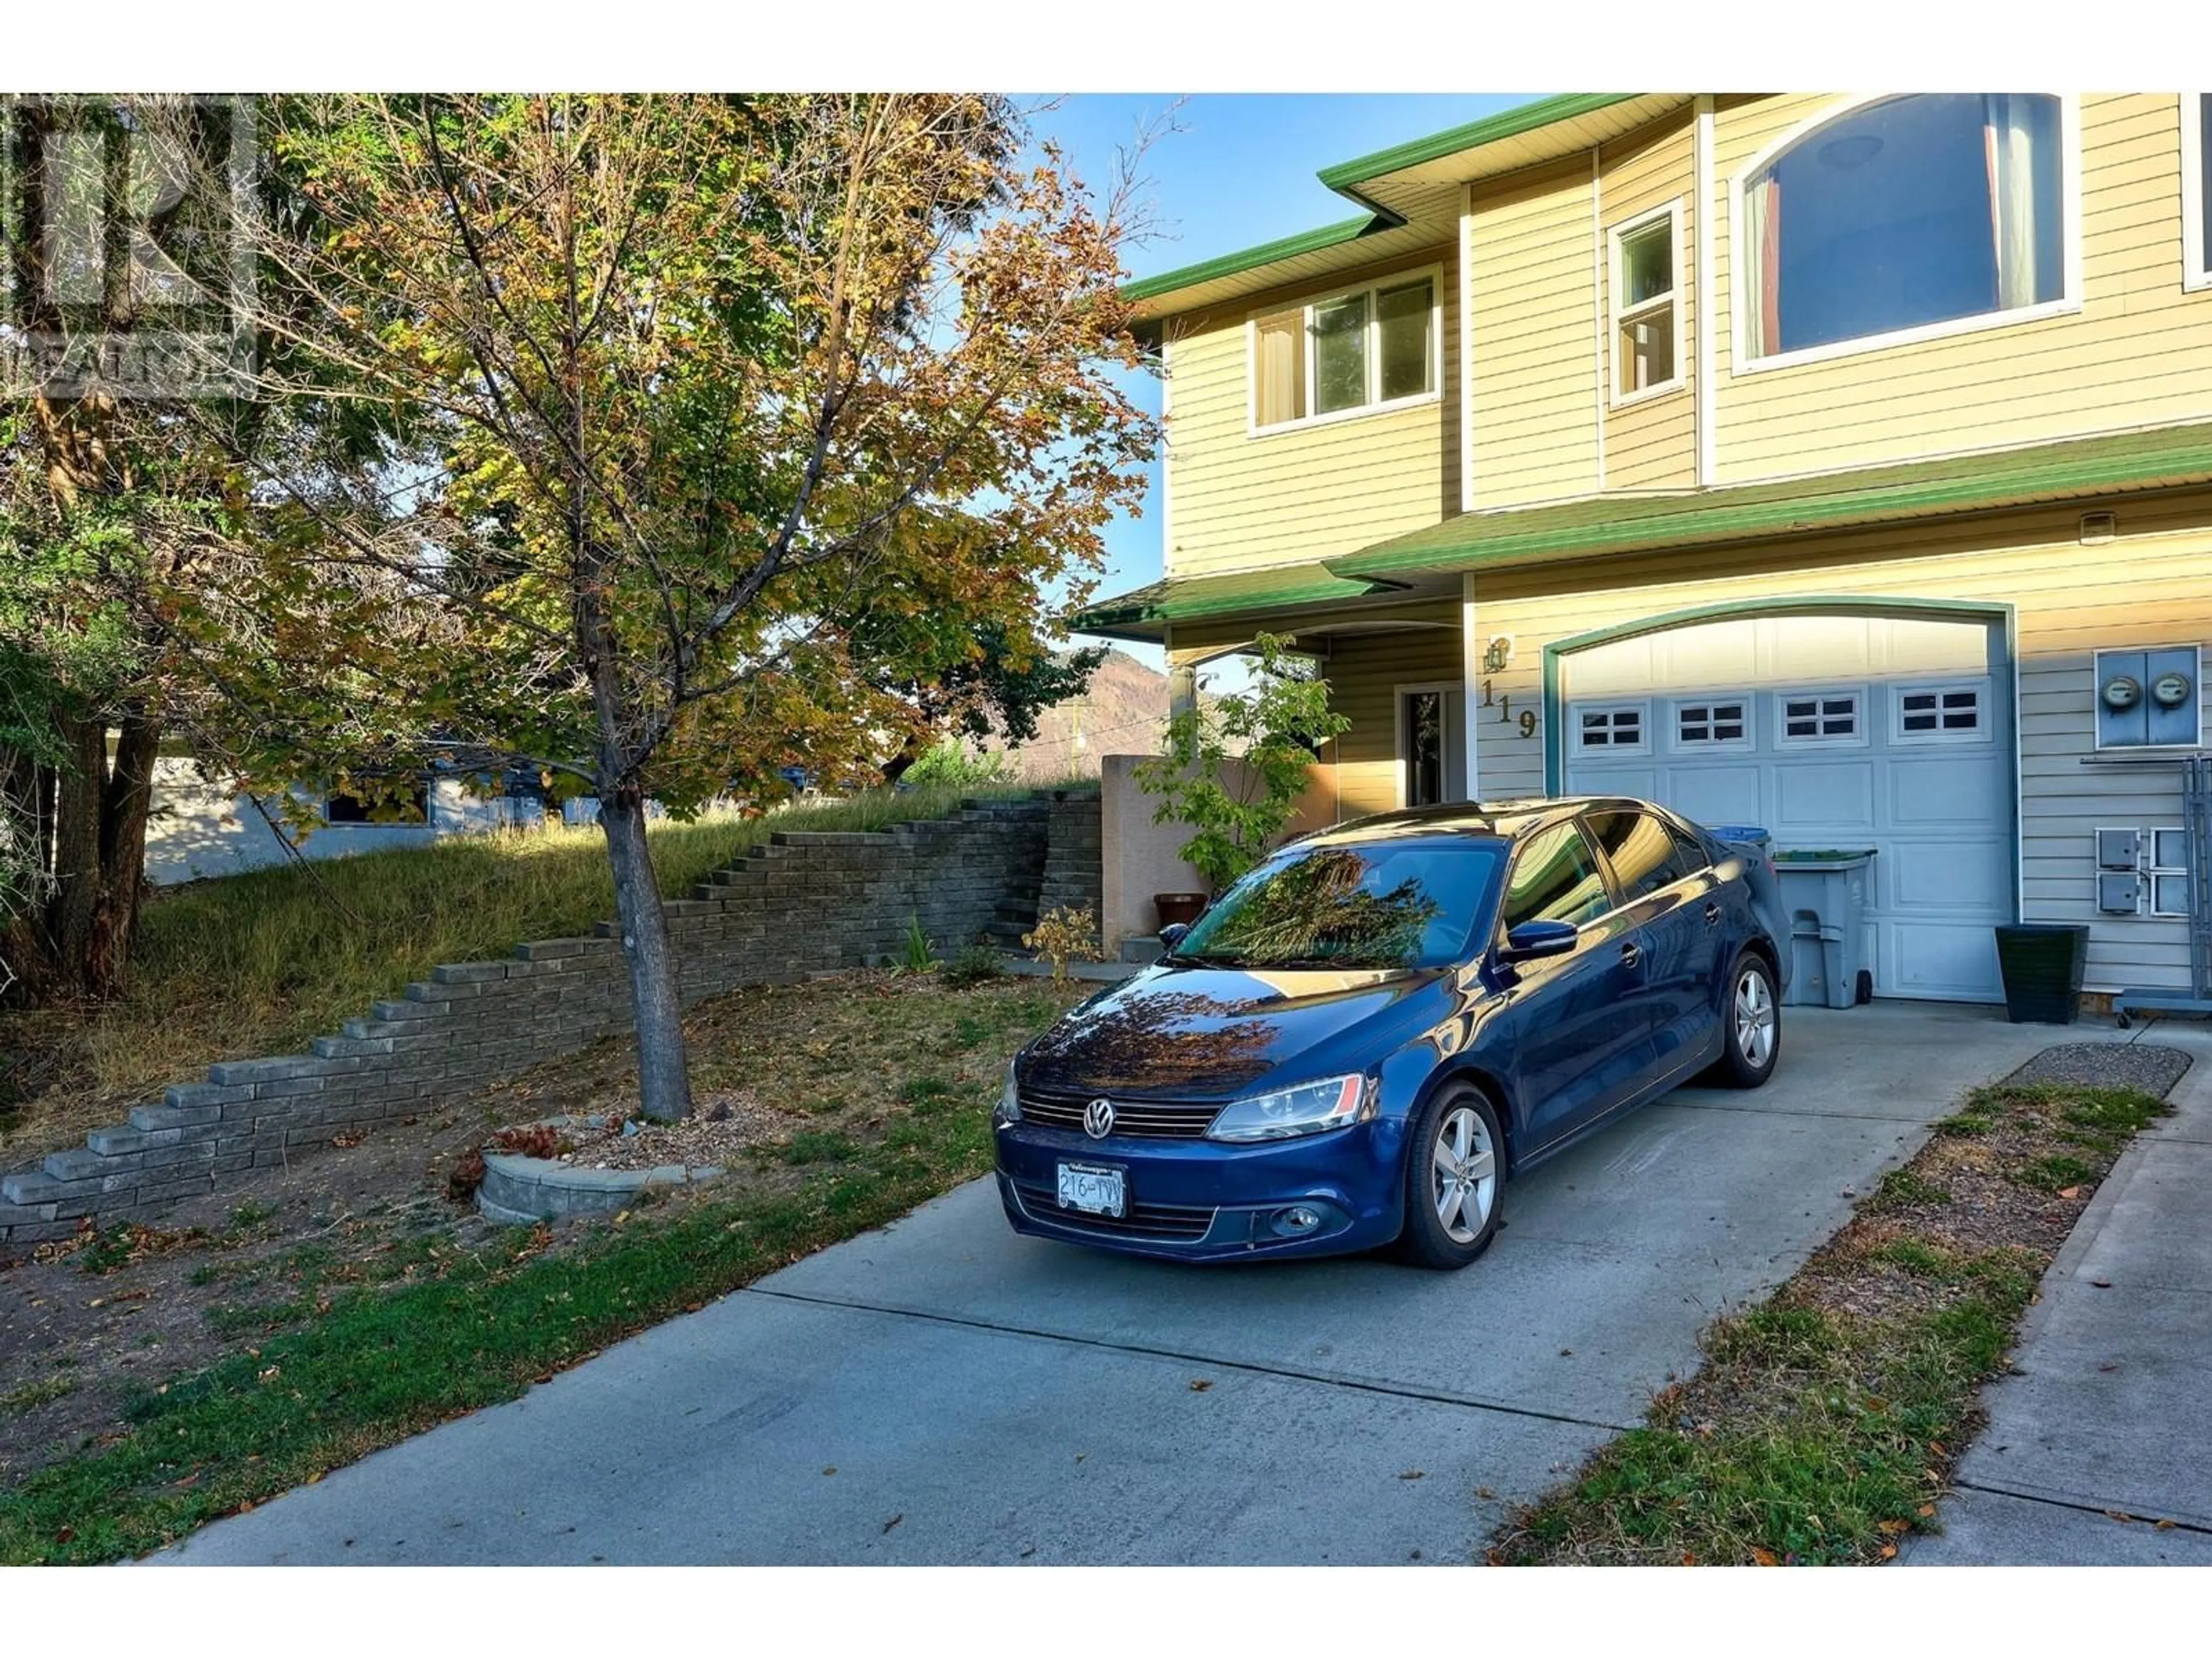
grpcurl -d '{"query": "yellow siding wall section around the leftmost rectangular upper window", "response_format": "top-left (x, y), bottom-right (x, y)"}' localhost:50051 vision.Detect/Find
top-left (1166, 245), bottom-right (1460, 577)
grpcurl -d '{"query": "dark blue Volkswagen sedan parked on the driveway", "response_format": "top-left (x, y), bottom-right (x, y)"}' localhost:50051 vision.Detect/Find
top-left (993, 798), bottom-right (1783, 1267)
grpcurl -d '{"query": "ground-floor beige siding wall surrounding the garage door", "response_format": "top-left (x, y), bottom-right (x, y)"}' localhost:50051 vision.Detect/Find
top-left (1475, 493), bottom-right (2212, 991)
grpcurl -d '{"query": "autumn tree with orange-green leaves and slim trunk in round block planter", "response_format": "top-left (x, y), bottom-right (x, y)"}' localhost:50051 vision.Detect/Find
top-left (164, 95), bottom-right (1153, 1119)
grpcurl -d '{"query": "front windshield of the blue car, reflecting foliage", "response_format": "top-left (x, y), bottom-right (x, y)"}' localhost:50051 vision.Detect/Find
top-left (1175, 834), bottom-right (1504, 969)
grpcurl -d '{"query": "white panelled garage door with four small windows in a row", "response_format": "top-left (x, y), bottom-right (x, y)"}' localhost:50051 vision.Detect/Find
top-left (1559, 615), bottom-right (2017, 1002)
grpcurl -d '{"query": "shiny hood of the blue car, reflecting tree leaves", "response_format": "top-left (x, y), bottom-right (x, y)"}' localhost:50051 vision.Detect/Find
top-left (1020, 962), bottom-right (1453, 1099)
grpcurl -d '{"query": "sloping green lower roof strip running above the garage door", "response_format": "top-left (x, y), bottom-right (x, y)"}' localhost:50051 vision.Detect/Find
top-left (1327, 422), bottom-right (2212, 577)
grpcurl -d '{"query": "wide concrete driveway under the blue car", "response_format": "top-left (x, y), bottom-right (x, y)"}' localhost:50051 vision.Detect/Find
top-left (166, 1004), bottom-right (2068, 1564)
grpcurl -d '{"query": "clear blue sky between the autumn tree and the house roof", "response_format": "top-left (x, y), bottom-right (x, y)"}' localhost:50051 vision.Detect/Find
top-left (1035, 93), bottom-right (1535, 661)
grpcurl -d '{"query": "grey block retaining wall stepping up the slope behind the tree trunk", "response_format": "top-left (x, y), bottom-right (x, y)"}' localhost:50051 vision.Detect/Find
top-left (0, 796), bottom-right (1053, 1245)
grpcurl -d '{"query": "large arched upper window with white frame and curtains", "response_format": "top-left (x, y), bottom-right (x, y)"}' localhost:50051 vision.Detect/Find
top-left (1738, 93), bottom-right (2066, 361)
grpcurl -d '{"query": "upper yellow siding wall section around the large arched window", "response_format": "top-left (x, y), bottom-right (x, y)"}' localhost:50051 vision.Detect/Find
top-left (1712, 93), bottom-right (2212, 484)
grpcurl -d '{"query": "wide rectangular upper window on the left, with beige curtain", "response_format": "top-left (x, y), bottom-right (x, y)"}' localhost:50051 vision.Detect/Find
top-left (1252, 274), bottom-right (1438, 431)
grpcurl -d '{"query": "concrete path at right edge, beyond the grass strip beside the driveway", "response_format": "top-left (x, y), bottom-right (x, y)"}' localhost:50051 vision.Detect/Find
top-left (1900, 1020), bottom-right (2212, 1566)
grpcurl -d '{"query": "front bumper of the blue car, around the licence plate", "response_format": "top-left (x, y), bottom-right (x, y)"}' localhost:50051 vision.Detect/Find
top-left (995, 1119), bottom-right (1404, 1261)
